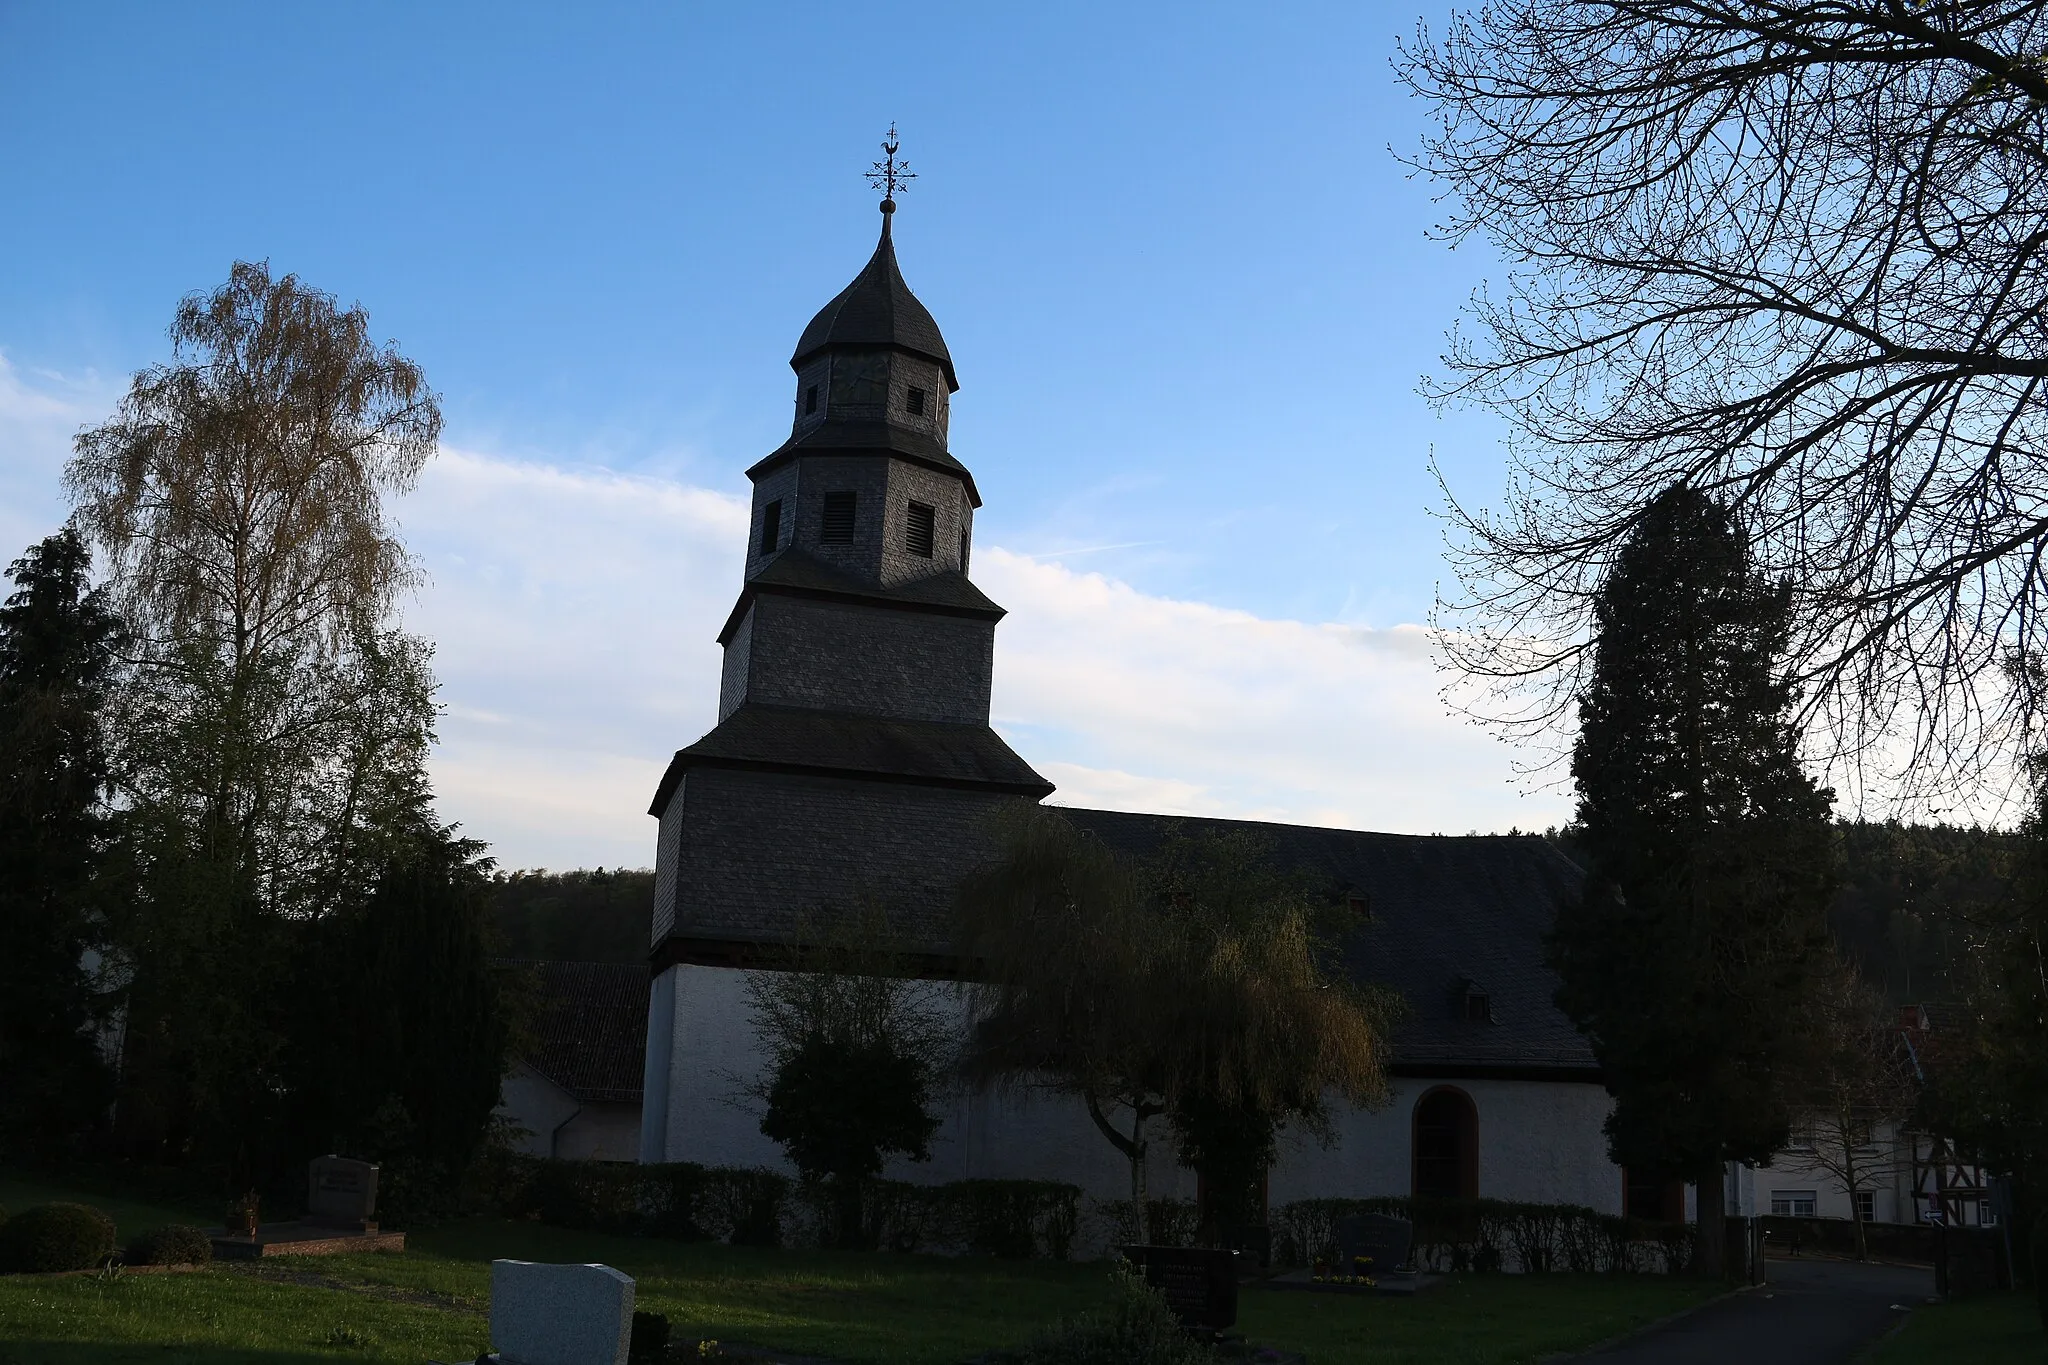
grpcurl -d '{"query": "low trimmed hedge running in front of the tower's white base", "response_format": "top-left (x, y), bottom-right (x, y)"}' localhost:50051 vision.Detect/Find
top-left (481, 1154), bottom-right (1081, 1261)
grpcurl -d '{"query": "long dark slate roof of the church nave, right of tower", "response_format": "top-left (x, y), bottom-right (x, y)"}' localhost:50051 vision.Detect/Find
top-left (1061, 808), bottom-right (1597, 1081)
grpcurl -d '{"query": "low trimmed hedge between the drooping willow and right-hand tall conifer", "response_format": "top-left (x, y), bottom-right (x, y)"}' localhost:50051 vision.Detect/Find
top-left (1272, 1197), bottom-right (1692, 1275)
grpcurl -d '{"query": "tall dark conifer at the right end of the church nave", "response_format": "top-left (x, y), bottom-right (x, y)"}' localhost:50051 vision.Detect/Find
top-left (1550, 487), bottom-right (1837, 1273)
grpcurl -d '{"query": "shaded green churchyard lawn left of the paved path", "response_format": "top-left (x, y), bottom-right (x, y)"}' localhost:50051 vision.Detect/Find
top-left (0, 1181), bottom-right (1710, 1365)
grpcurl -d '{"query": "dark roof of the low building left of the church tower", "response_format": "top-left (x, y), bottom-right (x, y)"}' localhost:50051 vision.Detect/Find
top-left (510, 962), bottom-right (647, 1105)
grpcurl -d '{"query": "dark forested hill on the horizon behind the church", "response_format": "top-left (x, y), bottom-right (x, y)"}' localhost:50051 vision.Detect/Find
top-left (492, 823), bottom-right (2015, 1003)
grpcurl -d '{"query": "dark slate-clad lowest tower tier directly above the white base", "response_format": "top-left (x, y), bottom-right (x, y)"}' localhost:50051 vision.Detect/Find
top-left (657, 767), bottom-right (1026, 950)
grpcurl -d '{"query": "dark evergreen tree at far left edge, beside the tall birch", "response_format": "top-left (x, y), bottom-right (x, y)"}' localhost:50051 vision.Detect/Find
top-left (0, 530), bottom-right (119, 1156)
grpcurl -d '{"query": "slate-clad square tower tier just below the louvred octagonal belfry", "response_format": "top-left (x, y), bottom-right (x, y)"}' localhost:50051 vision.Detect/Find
top-left (737, 593), bottom-right (995, 724)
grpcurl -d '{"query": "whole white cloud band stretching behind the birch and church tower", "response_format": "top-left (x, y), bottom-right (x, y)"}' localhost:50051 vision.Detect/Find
top-left (0, 356), bottom-right (1565, 868)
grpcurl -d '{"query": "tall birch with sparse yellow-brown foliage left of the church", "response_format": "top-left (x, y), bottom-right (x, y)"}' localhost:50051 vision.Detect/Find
top-left (66, 262), bottom-right (456, 1166)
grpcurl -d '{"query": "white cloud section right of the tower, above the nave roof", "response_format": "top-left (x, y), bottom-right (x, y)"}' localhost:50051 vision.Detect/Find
top-left (977, 551), bottom-right (1565, 833)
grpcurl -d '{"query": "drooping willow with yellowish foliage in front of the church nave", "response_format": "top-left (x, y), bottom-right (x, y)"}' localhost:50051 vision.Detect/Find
top-left (961, 808), bottom-right (1393, 1252)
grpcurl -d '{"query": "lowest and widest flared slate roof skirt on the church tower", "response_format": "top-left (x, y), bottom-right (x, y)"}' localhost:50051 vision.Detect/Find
top-left (647, 704), bottom-right (1053, 817)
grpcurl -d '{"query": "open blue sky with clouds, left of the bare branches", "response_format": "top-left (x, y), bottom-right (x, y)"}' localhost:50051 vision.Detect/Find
top-left (0, 0), bottom-right (1565, 866)
